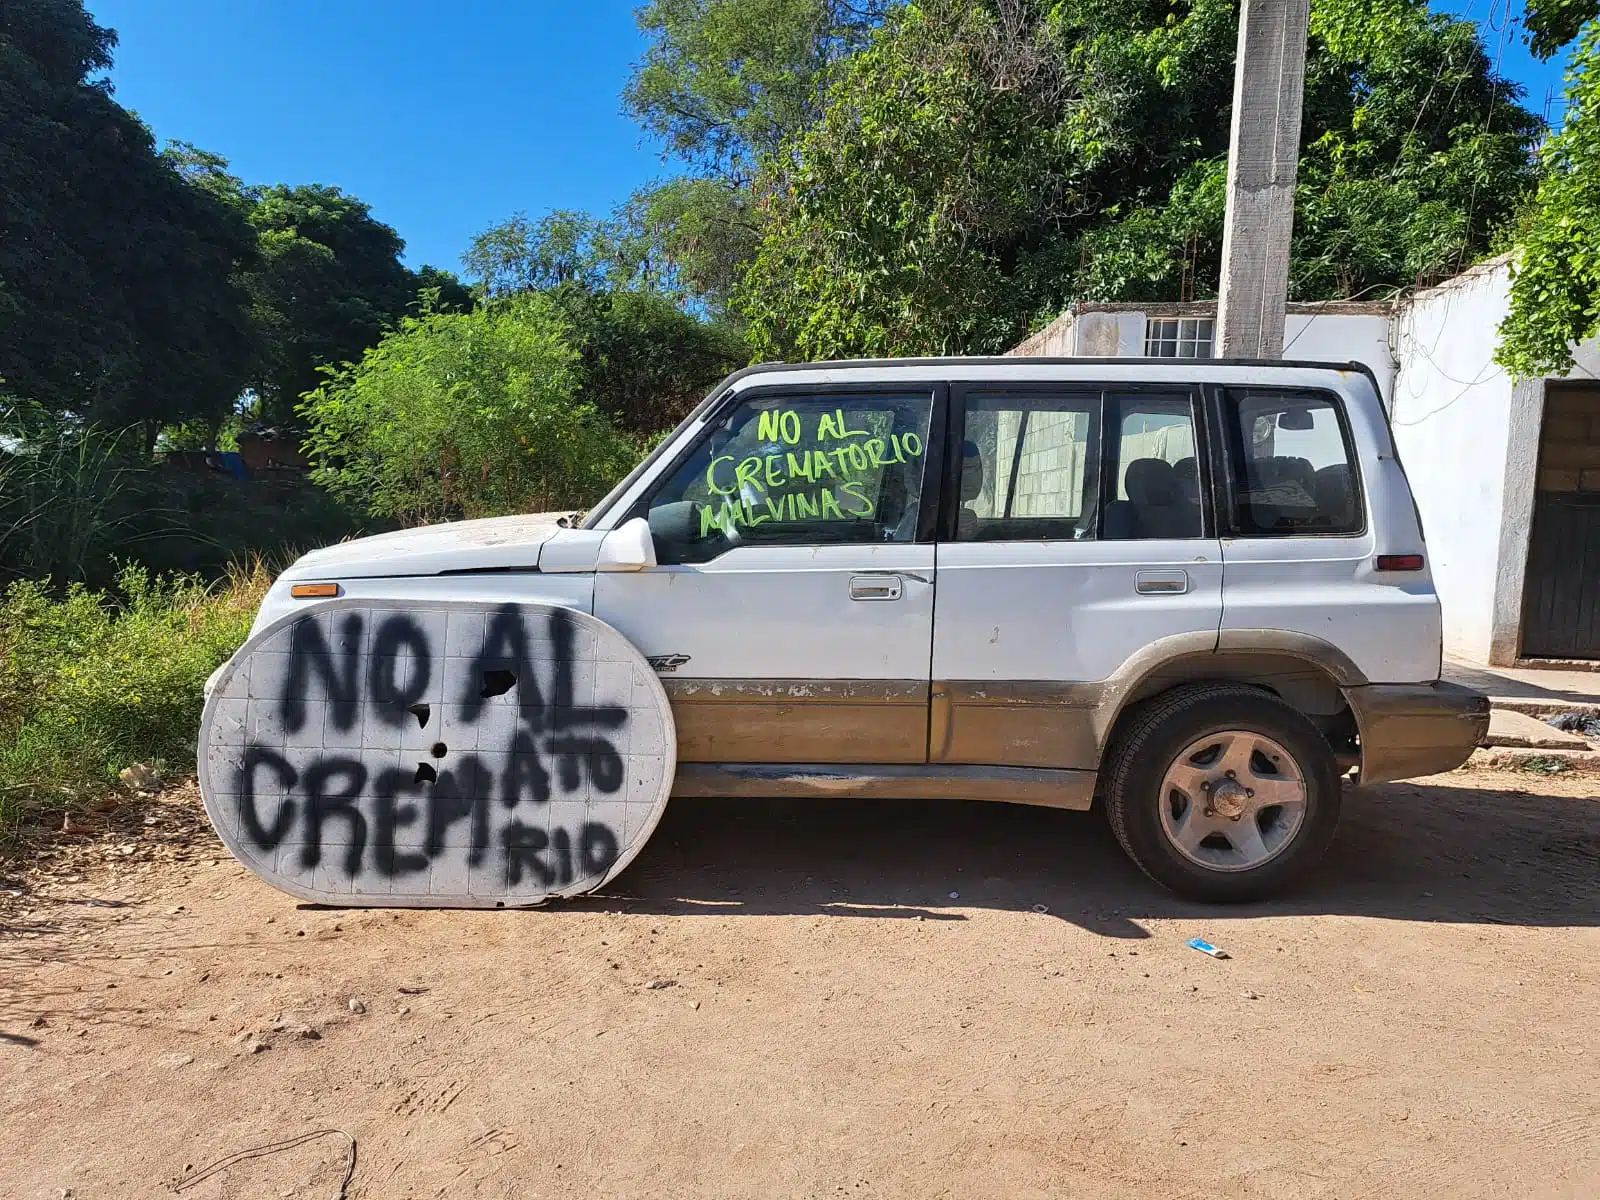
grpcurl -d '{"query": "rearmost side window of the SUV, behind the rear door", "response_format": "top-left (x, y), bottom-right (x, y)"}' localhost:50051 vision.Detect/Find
top-left (1222, 387), bottom-right (1365, 538)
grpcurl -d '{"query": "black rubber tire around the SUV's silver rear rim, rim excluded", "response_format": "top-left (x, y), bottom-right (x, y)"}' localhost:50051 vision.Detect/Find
top-left (1104, 683), bottom-right (1339, 904)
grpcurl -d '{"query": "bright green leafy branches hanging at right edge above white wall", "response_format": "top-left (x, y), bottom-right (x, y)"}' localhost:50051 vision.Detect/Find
top-left (1498, 0), bottom-right (1600, 376)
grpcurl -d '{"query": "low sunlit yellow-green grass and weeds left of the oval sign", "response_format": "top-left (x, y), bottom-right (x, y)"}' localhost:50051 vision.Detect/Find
top-left (0, 562), bottom-right (270, 834)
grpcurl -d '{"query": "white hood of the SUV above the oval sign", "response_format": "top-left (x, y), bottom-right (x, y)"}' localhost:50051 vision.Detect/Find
top-left (282, 512), bottom-right (571, 581)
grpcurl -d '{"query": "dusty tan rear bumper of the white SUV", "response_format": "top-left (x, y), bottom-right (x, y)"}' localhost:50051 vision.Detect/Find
top-left (1344, 680), bottom-right (1490, 784)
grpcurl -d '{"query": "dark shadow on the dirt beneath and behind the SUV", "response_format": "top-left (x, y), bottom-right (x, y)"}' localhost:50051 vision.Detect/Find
top-left (579, 784), bottom-right (1600, 938)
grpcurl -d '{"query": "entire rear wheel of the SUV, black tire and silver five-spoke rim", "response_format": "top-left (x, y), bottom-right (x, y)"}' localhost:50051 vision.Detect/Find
top-left (1106, 683), bottom-right (1339, 902)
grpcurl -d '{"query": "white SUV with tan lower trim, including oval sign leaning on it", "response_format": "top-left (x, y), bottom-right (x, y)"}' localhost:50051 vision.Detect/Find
top-left (202, 358), bottom-right (1488, 904)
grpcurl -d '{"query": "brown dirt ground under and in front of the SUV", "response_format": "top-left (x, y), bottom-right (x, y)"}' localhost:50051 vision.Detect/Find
top-left (0, 773), bottom-right (1600, 1200)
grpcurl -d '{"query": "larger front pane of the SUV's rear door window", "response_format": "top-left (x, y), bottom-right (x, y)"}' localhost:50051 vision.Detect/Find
top-left (955, 392), bottom-right (1099, 542)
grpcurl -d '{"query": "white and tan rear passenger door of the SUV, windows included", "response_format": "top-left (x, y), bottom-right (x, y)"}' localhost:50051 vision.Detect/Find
top-left (930, 382), bottom-right (1222, 770)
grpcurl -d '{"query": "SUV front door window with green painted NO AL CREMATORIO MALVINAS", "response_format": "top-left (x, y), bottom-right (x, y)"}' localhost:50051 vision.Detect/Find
top-left (648, 390), bottom-right (933, 563)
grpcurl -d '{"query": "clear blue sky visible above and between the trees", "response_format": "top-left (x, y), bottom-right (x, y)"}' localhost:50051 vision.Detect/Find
top-left (86, 0), bottom-right (1560, 269)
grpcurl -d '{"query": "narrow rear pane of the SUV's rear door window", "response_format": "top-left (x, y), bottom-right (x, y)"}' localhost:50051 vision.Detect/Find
top-left (1101, 392), bottom-right (1205, 541)
